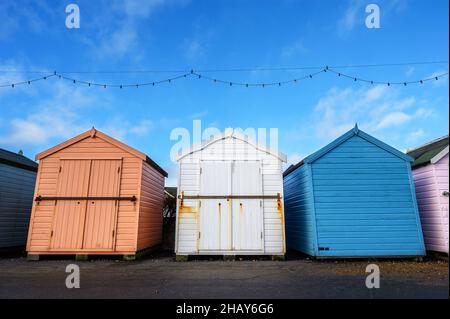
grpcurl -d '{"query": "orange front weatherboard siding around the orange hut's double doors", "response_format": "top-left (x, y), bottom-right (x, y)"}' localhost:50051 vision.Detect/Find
top-left (27, 137), bottom-right (142, 253)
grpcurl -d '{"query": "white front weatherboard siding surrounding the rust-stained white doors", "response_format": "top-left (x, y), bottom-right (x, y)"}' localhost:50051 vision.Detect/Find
top-left (176, 138), bottom-right (285, 254)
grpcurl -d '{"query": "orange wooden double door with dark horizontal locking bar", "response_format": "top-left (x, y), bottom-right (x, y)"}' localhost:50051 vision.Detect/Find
top-left (50, 159), bottom-right (122, 251)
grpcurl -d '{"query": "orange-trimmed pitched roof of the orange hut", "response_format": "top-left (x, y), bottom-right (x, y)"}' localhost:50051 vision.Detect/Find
top-left (36, 128), bottom-right (168, 177)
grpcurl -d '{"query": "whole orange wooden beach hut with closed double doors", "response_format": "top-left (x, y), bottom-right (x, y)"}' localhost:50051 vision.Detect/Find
top-left (27, 128), bottom-right (167, 259)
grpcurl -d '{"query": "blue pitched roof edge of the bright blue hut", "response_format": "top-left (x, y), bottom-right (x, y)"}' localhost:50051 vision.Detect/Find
top-left (283, 124), bottom-right (413, 177)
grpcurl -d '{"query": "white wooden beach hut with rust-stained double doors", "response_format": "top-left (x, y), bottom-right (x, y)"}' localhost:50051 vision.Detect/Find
top-left (175, 129), bottom-right (286, 260)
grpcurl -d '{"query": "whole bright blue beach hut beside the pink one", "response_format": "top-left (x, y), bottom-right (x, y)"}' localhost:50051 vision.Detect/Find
top-left (284, 126), bottom-right (425, 257)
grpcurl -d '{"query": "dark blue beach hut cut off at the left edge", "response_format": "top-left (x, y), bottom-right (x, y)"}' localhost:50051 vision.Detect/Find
top-left (0, 149), bottom-right (38, 250)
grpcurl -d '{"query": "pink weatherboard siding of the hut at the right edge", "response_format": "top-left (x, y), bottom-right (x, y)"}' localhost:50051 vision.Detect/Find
top-left (413, 154), bottom-right (449, 253)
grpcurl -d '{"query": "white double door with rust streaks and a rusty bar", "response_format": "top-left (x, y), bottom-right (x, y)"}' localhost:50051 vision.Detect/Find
top-left (198, 161), bottom-right (263, 252)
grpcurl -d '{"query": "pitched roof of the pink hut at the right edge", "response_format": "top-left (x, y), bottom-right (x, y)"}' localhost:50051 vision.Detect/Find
top-left (407, 135), bottom-right (449, 167)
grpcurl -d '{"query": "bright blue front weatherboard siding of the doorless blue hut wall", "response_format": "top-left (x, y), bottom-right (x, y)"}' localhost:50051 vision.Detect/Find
top-left (312, 135), bottom-right (423, 257)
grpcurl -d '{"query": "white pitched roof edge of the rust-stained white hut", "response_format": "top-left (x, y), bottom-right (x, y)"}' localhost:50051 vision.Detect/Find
top-left (177, 129), bottom-right (286, 162)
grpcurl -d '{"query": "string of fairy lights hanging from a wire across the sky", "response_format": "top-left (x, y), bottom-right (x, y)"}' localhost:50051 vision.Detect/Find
top-left (0, 62), bottom-right (448, 89)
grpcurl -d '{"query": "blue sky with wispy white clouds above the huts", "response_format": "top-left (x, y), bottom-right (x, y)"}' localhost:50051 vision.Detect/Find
top-left (0, 0), bottom-right (449, 185)
